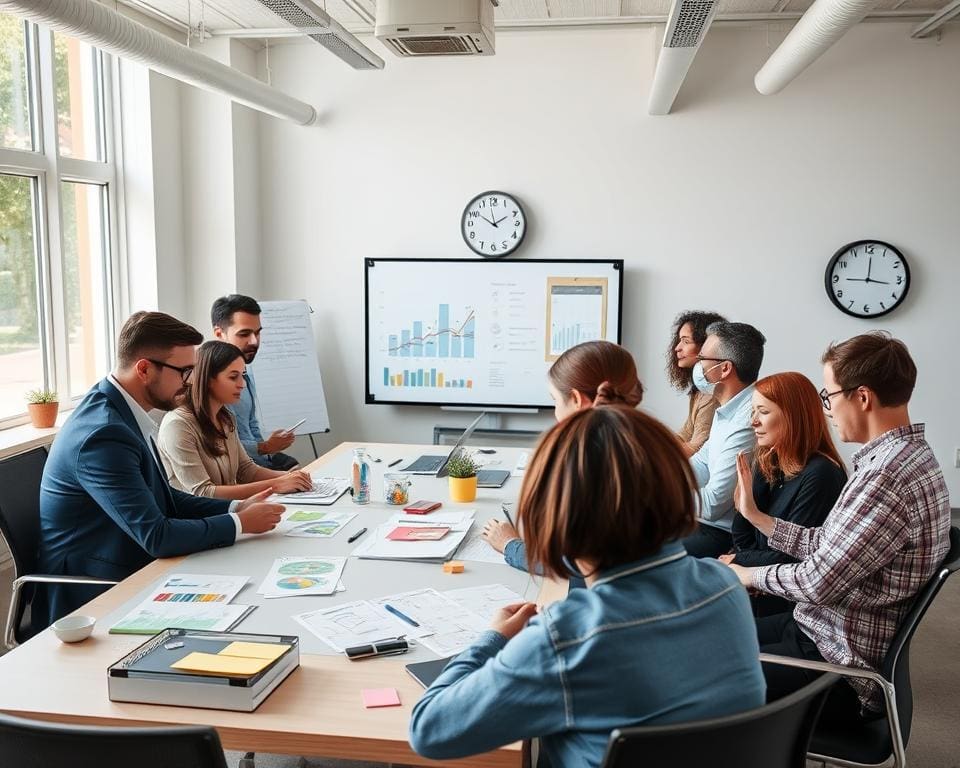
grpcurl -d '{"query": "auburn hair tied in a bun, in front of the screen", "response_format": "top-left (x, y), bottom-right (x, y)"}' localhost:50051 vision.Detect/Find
top-left (547, 341), bottom-right (643, 406)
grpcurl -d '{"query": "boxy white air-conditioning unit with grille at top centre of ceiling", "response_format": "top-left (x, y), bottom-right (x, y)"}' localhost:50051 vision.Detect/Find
top-left (375, 0), bottom-right (496, 58)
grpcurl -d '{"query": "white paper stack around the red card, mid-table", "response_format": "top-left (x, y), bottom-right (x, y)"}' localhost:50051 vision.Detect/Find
top-left (351, 509), bottom-right (476, 563)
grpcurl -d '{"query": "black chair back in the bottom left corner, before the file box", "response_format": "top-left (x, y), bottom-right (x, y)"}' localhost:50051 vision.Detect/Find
top-left (0, 714), bottom-right (227, 768)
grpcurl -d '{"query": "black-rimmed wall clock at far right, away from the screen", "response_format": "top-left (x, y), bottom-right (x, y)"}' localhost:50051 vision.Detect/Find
top-left (824, 240), bottom-right (910, 317)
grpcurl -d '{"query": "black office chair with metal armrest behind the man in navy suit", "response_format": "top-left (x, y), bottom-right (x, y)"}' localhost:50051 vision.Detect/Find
top-left (0, 447), bottom-right (117, 648)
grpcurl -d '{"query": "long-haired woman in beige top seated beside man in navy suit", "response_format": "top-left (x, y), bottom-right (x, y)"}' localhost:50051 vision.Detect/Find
top-left (157, 341), bottom-right (312, 499)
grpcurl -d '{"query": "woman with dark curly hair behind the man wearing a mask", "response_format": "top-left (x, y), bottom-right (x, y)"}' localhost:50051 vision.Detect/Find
top-left (667, 311), bottom-right (726, 456)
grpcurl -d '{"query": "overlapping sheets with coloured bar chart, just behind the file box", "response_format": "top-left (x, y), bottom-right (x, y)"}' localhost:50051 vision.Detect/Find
top-left (110, 573), bottom-right (254, 635)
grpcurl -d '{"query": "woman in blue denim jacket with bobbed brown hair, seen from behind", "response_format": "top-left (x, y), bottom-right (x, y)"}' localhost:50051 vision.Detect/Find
top-left (410, 404), bottom-right (765, 768)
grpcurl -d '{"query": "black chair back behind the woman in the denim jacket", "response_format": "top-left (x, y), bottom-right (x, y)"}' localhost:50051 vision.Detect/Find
top-left (602, 675), bottom-right (840, 768)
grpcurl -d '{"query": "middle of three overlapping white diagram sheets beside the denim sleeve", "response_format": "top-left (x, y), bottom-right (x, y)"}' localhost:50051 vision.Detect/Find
top-left (371, 589), bottom-right (489, 656)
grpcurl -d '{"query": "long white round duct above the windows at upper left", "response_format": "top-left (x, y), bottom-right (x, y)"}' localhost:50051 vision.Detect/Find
top-left (0, 0), bottom-right (317, 125)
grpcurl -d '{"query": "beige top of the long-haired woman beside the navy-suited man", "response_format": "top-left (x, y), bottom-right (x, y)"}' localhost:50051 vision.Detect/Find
top-left (157, 407), bottom-right (257, 496)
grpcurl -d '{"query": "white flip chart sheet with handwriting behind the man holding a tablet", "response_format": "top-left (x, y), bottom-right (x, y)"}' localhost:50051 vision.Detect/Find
top-left (250, 301), bottom-right (330, 436)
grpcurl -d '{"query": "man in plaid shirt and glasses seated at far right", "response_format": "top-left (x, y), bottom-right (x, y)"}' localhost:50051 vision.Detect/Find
top-left (730, 332), bottom-right (950, 718)
